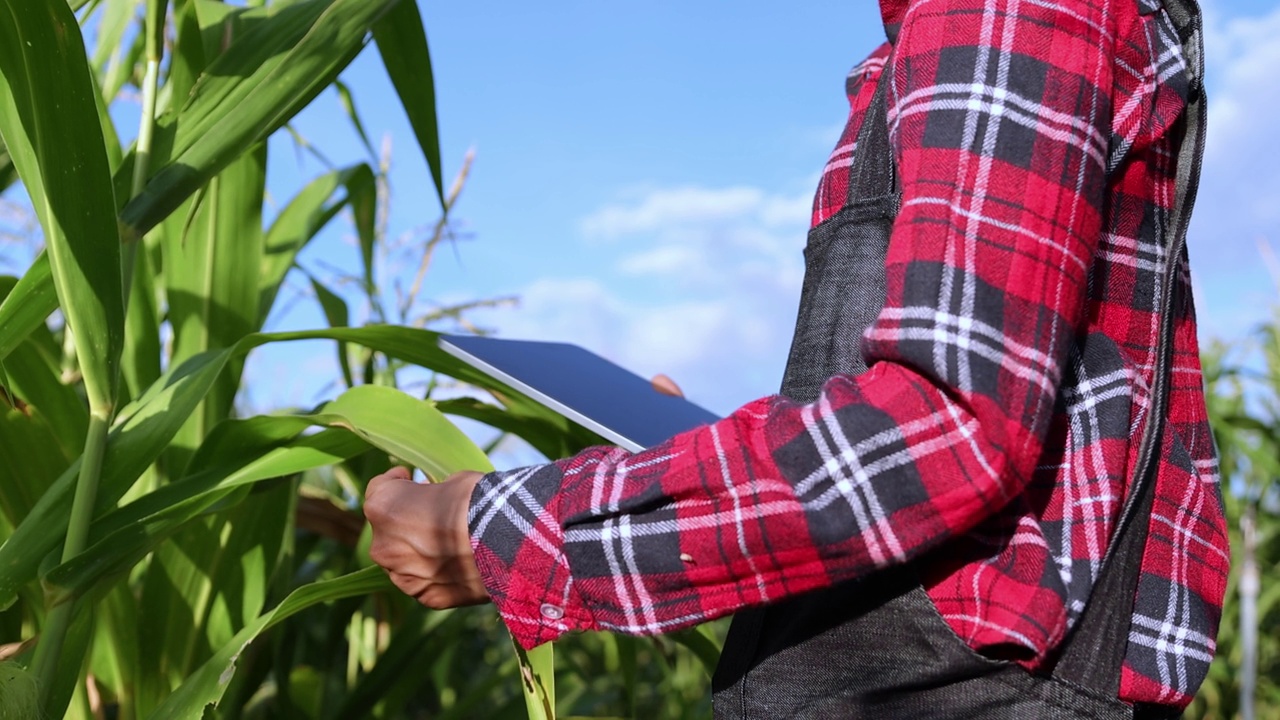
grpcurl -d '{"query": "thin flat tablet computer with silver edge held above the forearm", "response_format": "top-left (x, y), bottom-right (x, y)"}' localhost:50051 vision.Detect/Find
top-left (438, 334), bottom-right (719, 452)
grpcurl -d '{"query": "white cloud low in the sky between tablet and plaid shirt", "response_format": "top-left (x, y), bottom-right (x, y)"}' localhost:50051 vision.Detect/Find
top-left (484, 181), bottom-right (810, 413)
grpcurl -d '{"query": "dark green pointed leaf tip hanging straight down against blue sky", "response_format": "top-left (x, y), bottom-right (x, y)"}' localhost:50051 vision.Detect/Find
top-left (374, 0), bottom-right (444, 208)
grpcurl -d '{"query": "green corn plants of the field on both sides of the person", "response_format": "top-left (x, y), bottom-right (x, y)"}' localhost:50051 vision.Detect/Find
top-left (0, 0), bottom-right (1280, 720)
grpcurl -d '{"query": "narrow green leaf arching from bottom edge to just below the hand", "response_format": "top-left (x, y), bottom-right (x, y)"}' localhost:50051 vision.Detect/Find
top-left (150, 568), bottom-right (393, 720)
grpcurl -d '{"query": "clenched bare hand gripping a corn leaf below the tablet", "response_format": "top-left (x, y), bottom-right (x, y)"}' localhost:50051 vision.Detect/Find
top-left (365, 468), bottom-right (489, 610)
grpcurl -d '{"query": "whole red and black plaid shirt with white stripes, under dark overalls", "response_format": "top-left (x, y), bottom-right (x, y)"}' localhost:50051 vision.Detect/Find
top-left (471, 0), bottom-right (1229, 706)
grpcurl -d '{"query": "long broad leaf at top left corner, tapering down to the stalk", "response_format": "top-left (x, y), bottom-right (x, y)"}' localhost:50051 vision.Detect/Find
top-left (0, 0), bottom-right (124, 414)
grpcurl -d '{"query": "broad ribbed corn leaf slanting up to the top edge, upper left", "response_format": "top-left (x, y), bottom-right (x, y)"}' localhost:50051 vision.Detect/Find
top-left (116, 0), bottom-right (394, 237)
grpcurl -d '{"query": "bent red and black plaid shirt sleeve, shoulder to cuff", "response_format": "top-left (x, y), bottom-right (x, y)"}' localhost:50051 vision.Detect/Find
top-left (470, 0), bottom-right (1114, 647)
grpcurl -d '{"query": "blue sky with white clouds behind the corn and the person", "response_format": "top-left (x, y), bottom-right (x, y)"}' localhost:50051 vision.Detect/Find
top-left (250, 0), bottom-right (1280, 425)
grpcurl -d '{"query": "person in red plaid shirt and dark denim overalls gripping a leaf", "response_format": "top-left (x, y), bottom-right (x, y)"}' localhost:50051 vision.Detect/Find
top-left (366, 0), bottom-right (1229, 717)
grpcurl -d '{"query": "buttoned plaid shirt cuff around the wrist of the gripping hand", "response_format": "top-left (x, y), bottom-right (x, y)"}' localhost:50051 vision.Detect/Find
top-left (467, 464), bottom-right (594, 650)
